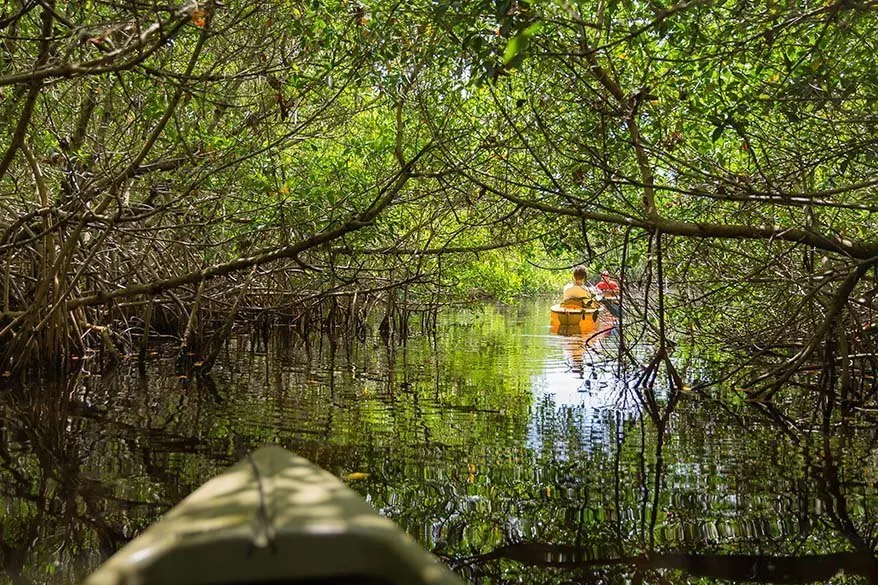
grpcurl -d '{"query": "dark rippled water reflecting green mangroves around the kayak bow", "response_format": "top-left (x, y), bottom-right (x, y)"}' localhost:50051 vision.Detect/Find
top-left (0, 301), bottom-right (878, 583)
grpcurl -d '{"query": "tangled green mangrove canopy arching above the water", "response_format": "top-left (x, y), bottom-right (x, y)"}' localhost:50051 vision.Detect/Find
top-left (0, 0), bottom-right (878, 397)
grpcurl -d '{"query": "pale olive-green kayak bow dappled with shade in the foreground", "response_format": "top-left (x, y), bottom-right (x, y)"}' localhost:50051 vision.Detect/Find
top-left (85, 446), bottom-right (462, 585)
